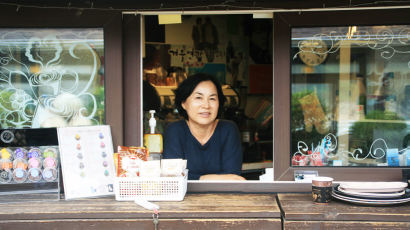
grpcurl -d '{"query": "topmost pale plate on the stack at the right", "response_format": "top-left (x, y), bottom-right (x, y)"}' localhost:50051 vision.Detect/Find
top-left (340, 182), bottom-right (407, 192)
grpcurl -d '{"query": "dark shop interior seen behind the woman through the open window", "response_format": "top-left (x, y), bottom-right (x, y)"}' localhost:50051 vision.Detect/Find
top-left (143, 14), bottom-right (273, 180)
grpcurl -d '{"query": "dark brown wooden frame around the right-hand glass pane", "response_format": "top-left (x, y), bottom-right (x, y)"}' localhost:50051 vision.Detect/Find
top-left (273, 9), bottom-right (410, 181)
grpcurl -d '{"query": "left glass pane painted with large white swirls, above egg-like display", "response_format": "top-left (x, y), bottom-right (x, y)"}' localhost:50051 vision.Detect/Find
top-left (0, 28), bottom-right (105, 128)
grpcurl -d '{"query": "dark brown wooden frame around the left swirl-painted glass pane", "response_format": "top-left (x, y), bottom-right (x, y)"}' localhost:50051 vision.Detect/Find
top-left (0, 6), bottom-right (126, 146)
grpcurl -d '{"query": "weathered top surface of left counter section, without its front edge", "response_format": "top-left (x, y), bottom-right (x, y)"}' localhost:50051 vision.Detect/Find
top-left (0, 194), bottom-right (281, 220)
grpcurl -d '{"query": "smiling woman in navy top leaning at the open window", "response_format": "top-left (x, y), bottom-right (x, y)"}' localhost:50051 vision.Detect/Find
top-left (163, 73), bottom-right (245, 180)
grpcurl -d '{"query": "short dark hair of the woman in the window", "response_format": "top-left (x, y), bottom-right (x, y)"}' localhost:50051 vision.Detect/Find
top-left (175, 73), bottom-right (225, 120)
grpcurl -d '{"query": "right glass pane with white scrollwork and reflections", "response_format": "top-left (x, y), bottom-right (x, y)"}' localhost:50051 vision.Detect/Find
top-left (290, 25), bottom-right (410, 167)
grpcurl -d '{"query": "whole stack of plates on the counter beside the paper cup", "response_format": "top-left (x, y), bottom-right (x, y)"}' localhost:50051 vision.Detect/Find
top-left (332, 182), bottom-right (410, 205)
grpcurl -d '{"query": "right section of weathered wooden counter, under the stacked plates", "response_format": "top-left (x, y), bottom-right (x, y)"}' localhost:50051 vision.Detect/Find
top-left (278, 194), bottom-right (410, 230)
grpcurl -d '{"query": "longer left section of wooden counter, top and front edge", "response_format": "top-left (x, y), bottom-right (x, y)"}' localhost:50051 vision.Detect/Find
top-left (0, 194), bottom-right (281, 230)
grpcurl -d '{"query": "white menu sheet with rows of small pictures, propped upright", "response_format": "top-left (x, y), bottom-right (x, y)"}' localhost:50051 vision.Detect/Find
top-left (57, 125), bottom-right (115, 200)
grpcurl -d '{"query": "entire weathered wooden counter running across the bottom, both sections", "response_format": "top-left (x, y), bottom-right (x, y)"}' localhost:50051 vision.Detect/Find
top-left (0, 193), bottom-right (410, 230)
